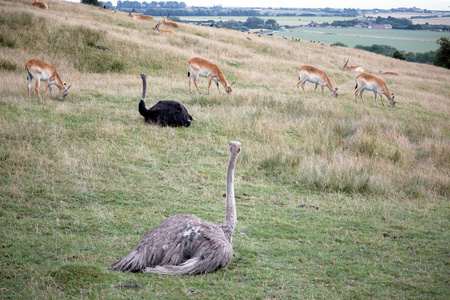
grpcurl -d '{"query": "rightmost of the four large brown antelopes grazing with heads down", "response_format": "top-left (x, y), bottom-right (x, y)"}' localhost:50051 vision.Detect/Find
top-left (355, 73), bottom-right (396, 108)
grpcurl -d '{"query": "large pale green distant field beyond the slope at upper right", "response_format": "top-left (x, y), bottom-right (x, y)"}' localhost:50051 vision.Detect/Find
top-left (275, 27), bottom-right (450, 52)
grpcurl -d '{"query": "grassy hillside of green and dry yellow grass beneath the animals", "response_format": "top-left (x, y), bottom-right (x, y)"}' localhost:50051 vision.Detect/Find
top-left (0, 0), bottom-right (450, 299)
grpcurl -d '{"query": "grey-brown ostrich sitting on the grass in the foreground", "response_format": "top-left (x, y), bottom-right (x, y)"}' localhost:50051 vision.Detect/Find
top-left (108, 141), bottom-right (241, 275)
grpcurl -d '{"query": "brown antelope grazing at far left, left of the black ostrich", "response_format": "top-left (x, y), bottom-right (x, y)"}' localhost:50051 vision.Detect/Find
top-left (25, 58), bottom-right (72, 100)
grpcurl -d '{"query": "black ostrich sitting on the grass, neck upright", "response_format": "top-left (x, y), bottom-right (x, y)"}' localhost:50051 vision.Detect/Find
top-left (139, 73), bottom-right (193, 127)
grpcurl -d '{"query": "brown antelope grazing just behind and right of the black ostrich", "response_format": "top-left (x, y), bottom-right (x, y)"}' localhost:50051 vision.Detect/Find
top-left (188, 57), bottom-right (234, 95)
